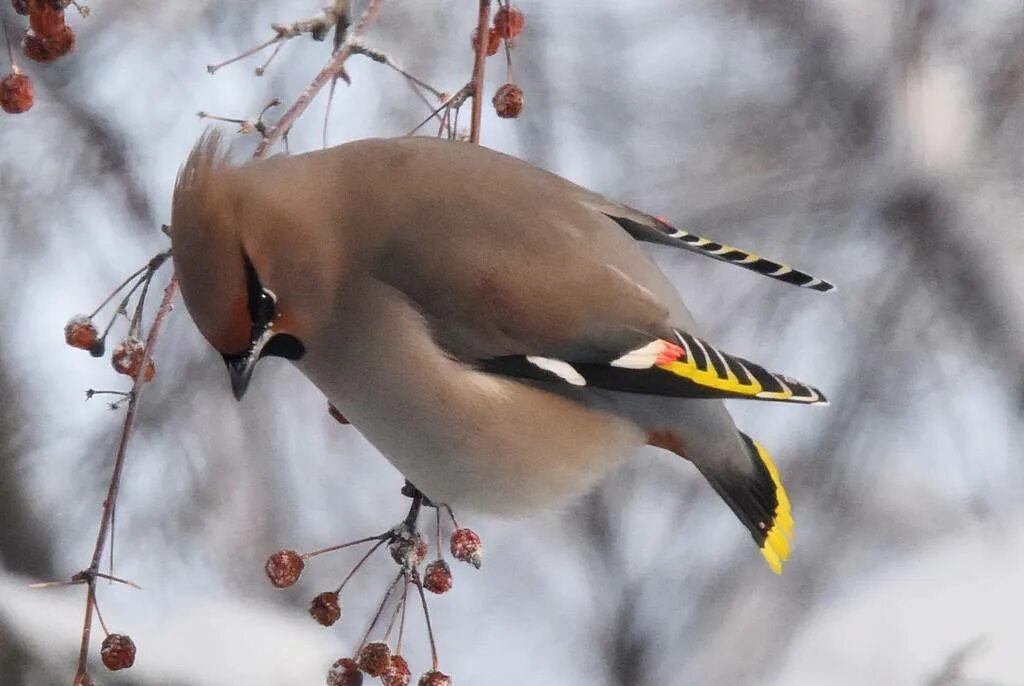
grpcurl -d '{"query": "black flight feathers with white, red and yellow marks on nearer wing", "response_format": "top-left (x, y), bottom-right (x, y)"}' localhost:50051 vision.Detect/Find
top-left (480, 329), bottom-right (828, 404)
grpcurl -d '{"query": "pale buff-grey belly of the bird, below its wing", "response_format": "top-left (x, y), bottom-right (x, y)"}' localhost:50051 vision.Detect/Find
top-left (307, 362), bottom-right (646, 514)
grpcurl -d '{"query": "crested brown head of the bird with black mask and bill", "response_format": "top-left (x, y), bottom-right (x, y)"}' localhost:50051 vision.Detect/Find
top-left (171, 133), bottom-right (331, 399)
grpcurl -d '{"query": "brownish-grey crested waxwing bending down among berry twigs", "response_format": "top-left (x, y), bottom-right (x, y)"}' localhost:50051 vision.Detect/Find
top-left (171, 130), bottom-right (835, 573)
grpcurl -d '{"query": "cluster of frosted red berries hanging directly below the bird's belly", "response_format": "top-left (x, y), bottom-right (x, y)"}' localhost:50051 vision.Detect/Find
top-left (265, 516), bottom-right (483, 686)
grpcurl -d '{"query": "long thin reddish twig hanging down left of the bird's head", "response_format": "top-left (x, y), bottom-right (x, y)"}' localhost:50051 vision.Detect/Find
top-left (75, 274), bottom-right (178, 681)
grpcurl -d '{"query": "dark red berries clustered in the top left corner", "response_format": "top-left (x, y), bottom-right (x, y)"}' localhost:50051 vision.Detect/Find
top-left (0, 0), bottom-right (81, 115)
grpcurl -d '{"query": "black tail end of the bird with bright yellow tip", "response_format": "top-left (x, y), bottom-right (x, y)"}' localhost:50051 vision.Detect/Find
top-left (697, 432), bottom-right (793, 574)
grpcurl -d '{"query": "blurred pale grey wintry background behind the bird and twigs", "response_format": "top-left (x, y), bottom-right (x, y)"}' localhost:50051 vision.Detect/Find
top-left (0, 0), bottom-right (1024, 686)
